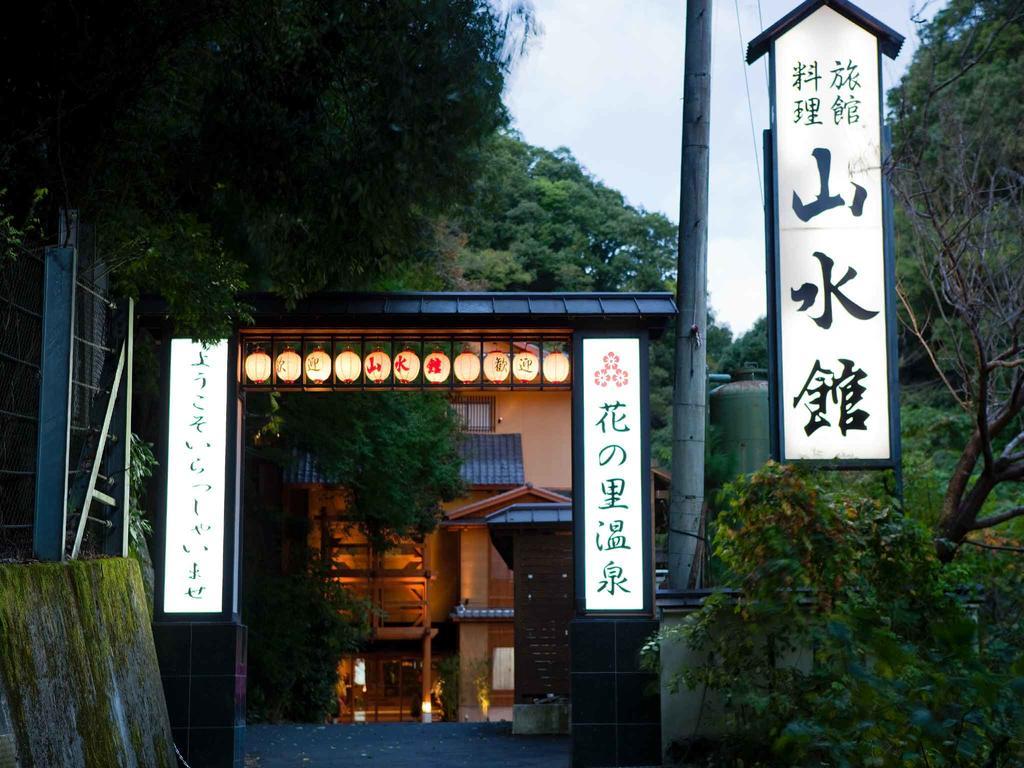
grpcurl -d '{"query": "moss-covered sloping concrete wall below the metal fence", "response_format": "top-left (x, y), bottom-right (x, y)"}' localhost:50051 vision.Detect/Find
top-left (0, 558), bottom-right (175, 768)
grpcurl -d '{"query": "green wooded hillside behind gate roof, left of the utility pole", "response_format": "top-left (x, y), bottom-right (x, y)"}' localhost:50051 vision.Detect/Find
top-left (449, 131), bottom-right (677, 291)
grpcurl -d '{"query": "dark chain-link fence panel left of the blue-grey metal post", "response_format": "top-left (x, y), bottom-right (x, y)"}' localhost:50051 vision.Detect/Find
top-left (0, 251), bottom-right (43, 560)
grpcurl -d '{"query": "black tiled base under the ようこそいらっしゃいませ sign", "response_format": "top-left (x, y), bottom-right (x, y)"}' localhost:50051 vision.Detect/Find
top-left (153, 623), bottom-right (246, 768)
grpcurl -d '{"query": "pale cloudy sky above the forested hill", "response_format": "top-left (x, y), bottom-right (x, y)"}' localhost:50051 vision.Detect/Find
top-left (506, 0), bottom-right (934, 334)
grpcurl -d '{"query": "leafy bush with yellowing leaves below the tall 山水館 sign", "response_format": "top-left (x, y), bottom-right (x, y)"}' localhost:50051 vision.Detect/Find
top-left (645, 464), bottom-right (1024, 767)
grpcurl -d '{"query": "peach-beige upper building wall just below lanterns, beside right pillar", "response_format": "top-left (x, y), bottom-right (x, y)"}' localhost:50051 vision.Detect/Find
top-left (495, 390), bottom-right (572, 488)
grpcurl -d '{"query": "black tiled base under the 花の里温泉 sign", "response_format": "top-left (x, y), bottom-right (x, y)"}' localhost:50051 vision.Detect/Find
top-left (569, 617), bottom-right (662, 768)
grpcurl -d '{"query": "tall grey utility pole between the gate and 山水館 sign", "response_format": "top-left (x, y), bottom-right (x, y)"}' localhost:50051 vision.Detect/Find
top-left (669, 0), bottom-right (712, 590)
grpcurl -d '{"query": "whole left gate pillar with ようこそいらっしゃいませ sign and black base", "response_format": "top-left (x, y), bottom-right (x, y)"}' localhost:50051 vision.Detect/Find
top-left (153, 336), bottom-right (246, 768)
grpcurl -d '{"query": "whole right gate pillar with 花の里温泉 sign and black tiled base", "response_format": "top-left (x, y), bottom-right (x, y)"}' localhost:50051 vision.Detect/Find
top-left (569, 330), bottom-right (662, 768)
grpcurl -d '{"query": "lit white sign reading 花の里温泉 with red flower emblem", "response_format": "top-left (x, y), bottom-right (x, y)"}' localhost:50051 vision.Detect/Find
top-left (575, 337), bottom-right (648, 612)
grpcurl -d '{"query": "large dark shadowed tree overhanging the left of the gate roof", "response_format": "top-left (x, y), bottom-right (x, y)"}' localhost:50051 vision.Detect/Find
top-left (0, 0), bottom-right (530, 337)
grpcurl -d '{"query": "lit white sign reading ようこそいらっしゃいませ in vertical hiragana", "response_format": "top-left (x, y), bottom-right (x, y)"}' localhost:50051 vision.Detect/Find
top-left (163, 339), bottom-right (227, 613)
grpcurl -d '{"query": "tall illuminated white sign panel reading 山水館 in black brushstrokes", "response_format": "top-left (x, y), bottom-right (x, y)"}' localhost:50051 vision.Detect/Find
top-left (769, 5), bottom-right (894, 464)
